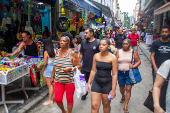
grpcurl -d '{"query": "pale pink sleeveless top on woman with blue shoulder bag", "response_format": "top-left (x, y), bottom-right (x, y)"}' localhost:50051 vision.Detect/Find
top-left (118, 49), bottom-right (133, 71)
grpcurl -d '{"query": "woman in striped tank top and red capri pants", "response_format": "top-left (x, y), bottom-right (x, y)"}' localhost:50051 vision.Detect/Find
top-left (51, 33), bottom-right (81, 113)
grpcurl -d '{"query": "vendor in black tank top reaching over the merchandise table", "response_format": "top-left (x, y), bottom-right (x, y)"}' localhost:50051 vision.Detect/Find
top-left (8, 31), bottom-right (41, 57)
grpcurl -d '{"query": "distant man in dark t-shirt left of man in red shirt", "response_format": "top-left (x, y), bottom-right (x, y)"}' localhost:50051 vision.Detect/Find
top-left (114, 28), bottom-right (126, 50)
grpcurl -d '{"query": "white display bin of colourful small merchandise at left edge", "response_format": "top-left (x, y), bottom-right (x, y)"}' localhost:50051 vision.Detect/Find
top-left (0, 57), bottom-right (29, 85)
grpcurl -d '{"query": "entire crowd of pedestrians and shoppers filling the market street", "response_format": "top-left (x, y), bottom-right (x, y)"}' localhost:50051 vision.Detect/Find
top-left (6, 26), bottom-right (170, 113)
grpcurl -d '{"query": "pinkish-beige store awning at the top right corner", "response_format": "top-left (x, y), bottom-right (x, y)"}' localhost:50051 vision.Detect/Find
top-left (154, 2), bottom-right (170, 15)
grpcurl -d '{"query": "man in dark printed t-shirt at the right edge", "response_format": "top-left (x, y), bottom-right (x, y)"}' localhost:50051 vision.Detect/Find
top-left (150, 25), bottom-right (170, 83)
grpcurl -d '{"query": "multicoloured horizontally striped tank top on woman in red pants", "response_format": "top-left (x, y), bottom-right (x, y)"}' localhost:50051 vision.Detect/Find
top-left (54, 49), bottom-right (74, 84)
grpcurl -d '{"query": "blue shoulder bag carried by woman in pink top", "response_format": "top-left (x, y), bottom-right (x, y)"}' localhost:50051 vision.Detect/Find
top-left (129, 50), bottom-right (142, 84)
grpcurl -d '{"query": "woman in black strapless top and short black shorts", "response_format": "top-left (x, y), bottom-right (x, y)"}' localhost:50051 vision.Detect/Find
top-left (88, 38), bottom-right (118, 113)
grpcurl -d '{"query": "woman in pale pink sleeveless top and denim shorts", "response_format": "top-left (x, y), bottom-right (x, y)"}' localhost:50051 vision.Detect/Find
top-left (116, 39), bottom-right (141, 113)
